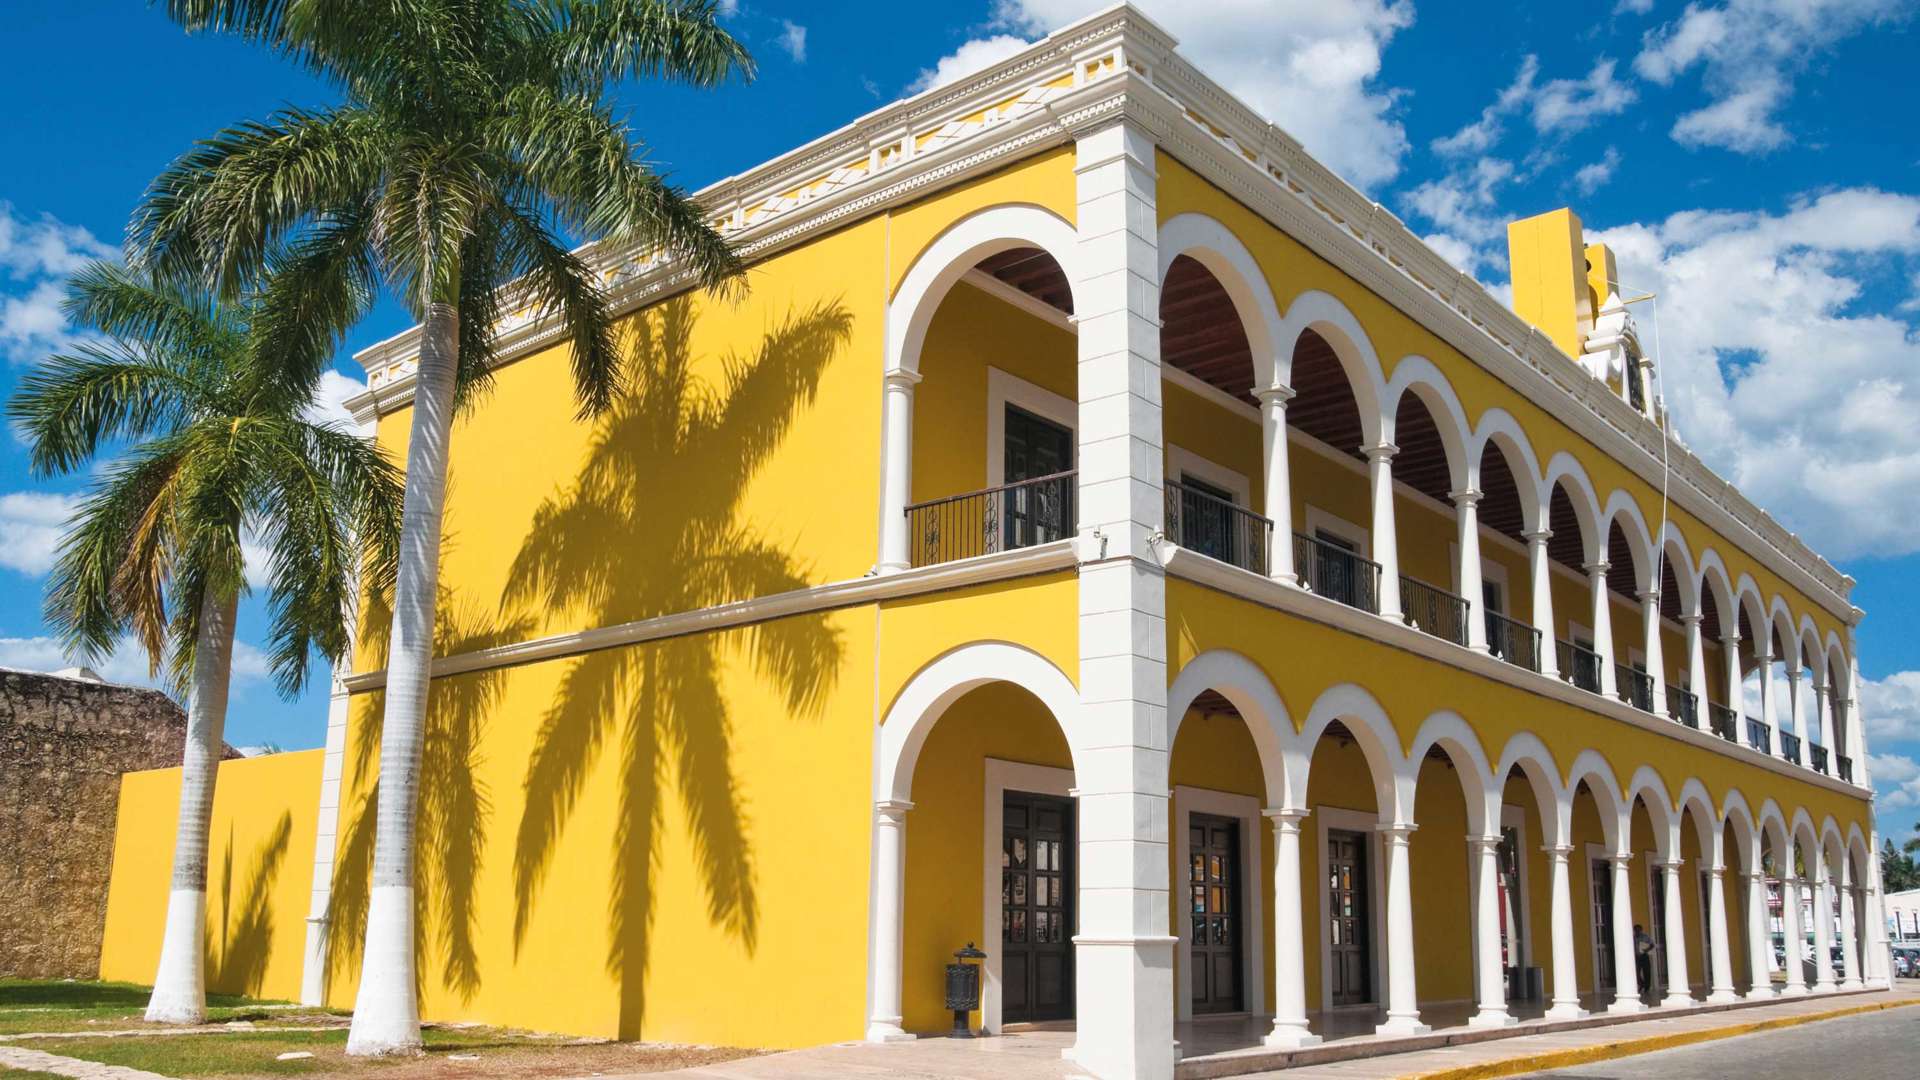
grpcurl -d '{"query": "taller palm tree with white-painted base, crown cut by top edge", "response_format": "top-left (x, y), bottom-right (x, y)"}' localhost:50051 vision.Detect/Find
top-left (131, 0), bottom-right (753, 1053)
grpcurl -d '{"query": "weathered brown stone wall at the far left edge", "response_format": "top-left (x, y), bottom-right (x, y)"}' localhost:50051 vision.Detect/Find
top-left (0, 669), bottom-right (186, 978)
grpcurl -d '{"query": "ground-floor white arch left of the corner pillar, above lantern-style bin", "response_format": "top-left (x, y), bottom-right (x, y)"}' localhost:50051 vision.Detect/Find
top-left (874, 642), bottom-right (1089, 803)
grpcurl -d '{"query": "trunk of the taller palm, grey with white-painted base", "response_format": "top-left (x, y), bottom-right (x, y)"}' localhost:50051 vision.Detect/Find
top-left (348, 304), bottom-right (459, 1055)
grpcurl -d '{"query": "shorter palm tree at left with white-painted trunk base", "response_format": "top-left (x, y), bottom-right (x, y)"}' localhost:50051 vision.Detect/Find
top-left (8, 263), bottom-right (399, 1024)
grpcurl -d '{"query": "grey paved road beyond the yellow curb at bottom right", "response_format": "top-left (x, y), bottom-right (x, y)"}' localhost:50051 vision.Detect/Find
top-left (1532, 1009), bottom-right (1920, 1080)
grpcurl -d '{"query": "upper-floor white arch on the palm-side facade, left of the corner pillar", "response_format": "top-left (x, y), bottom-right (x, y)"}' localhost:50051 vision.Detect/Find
top-left (885, 204), bottom-right (1083, 373)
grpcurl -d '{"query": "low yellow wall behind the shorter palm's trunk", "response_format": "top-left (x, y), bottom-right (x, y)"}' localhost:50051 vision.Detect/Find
top-left (100, 749), bottom-right (324, 999)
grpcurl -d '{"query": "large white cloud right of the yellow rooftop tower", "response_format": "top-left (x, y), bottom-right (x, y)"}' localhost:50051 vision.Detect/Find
top-left (1590, 188), bottom-right (1920, 557)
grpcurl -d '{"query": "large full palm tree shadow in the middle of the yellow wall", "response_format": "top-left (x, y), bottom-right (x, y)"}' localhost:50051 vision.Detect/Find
top-left (501, 298), bottom-right (852, 1038)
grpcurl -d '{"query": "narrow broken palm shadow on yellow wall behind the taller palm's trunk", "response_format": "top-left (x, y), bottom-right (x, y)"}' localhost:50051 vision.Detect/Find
top-left (326, 584), bottom-right (532, 1001)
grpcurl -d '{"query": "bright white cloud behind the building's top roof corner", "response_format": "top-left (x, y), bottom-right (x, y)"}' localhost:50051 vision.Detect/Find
top-left (916, 0), bottom-right (1413, 186)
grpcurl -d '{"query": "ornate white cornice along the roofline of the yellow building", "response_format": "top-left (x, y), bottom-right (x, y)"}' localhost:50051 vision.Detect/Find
top-left (348, 6), bottom-right (1857, 623)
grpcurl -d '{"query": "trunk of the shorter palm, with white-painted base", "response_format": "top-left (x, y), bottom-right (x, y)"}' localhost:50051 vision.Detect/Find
top-left (146, 590), bottom-right (238, 1024)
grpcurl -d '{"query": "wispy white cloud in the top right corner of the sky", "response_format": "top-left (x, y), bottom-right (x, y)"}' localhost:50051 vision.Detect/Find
top-left (1634, 0), bottom-right (1910, 154)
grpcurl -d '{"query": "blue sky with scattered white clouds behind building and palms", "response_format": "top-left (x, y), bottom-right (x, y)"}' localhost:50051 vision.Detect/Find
top-left (0, 0), bottom-right (1920, 836)
